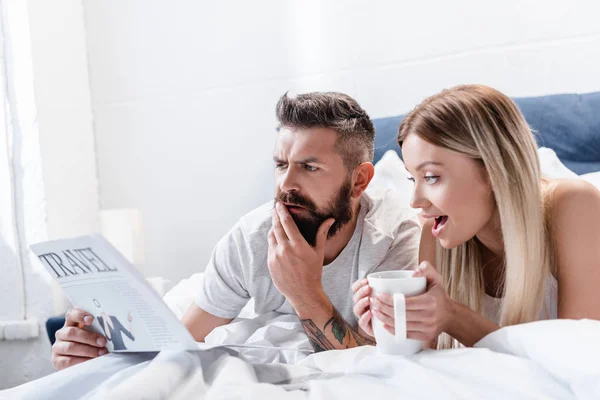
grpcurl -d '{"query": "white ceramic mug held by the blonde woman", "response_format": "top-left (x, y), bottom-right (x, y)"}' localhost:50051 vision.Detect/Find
top-left (367, 271), bottom-right (427, 356)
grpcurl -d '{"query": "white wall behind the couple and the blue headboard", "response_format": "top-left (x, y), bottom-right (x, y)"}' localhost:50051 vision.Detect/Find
top-left (84, 0), bottom-right (600, 280)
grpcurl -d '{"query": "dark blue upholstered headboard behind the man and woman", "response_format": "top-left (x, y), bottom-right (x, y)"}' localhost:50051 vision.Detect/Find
top-left (373, 92), bottom-right (600, 175)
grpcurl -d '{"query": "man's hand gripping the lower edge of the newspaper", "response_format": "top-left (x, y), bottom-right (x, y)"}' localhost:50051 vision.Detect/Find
top-left (52, 308), bottom-right (108, 370)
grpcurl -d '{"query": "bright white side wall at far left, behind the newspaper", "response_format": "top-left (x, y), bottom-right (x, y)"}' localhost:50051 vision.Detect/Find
top-left (0, 0), bottom-right (99, 389)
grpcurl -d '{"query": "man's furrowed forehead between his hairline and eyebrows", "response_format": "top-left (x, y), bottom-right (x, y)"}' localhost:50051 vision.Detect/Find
top-left (275, 127), bottom-right (337, 159)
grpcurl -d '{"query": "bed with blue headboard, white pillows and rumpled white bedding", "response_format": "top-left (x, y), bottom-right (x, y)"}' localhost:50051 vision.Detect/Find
top-left (0, 93), bottom-right (600, 399)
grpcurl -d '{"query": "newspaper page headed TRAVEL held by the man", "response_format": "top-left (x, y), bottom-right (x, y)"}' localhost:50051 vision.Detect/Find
top-left (31, 234), bottom-right (202, 352)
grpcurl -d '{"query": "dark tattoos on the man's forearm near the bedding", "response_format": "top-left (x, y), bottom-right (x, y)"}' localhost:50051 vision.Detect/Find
top-left (300, 308), bottom-right (375, 352)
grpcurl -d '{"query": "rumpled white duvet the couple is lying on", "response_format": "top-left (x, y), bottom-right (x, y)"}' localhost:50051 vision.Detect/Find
top-left (0, 313), bottom-right (600, 400)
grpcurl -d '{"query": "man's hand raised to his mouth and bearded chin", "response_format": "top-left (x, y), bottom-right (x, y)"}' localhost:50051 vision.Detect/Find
top-left (268, 202), bottom-right (335, 308)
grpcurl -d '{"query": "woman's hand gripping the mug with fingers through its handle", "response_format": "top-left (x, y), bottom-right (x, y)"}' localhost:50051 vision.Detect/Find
top-left (370, 262), bottom-right (454, 343)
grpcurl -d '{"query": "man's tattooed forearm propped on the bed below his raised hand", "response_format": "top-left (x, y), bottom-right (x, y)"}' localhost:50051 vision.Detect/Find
top-left (294, 293), bottom-right (375, 351)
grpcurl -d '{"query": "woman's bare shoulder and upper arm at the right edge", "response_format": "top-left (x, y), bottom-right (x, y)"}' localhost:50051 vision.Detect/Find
top-left (551, 180), bottom-right (600, 320)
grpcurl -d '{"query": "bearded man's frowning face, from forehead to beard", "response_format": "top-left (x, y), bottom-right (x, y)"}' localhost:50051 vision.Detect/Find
top-left (273, 127), bottom-right (352, 246)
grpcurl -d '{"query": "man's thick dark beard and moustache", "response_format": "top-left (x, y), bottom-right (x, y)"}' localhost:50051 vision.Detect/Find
top-left (275, 178), bottom-right (352, 247)
